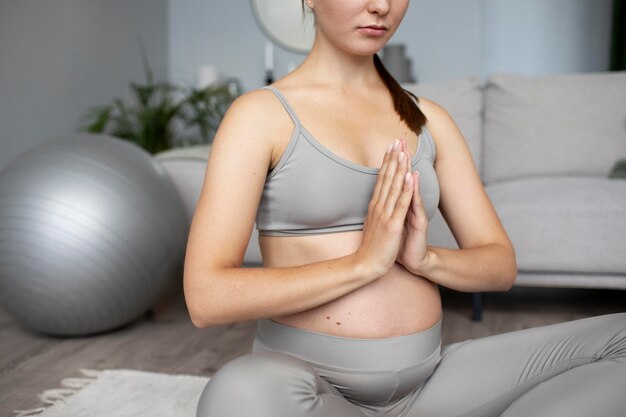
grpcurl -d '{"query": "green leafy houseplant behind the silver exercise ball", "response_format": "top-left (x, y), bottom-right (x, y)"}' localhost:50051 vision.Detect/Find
top-left (81, 60), bottom-right (241, 154)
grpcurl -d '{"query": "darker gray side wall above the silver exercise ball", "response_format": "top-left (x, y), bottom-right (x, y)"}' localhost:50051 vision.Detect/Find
top-left (0, 0), bottom-right (168, 170)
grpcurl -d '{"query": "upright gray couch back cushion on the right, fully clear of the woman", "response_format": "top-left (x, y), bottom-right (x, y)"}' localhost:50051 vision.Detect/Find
top-left (483, 72), bottom-right (626, 183)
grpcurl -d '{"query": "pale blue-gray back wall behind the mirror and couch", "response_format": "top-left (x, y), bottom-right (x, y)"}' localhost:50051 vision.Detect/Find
top-left (168, 0), bottom-right (612, 90)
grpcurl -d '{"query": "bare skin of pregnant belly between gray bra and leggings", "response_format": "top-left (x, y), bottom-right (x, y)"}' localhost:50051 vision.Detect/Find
top-left (259, 231), bottom-right (441, 339)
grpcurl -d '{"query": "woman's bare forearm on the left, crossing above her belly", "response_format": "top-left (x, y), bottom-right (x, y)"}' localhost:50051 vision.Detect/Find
top-left (184, 254), bottom-right (378, 327)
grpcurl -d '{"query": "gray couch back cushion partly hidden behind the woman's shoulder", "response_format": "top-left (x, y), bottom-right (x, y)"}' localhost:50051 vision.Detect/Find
top-left (402, 77), bottom-right (482, 172)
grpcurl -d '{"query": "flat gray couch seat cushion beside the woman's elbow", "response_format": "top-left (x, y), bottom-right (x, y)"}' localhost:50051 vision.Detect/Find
top-left (486, 176), bottom-right (626, 275)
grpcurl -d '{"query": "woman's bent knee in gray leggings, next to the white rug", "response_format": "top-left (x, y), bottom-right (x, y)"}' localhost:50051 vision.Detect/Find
top-left (197, 352), bottom-right (318, 417)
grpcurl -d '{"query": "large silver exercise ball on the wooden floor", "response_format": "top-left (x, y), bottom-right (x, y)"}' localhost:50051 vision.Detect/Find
top-left (0, 135), bottom-right (187, 336)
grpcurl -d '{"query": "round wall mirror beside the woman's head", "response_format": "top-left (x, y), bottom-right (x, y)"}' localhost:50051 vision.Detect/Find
top-left (250, 0), bottom-right (315, 53)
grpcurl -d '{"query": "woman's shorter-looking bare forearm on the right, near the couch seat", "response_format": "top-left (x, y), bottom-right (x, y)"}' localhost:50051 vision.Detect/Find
top-left (410, 243), bottom-right (517, 292)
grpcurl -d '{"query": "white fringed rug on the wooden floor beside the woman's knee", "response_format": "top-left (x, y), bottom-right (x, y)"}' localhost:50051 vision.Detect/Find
top-left (15, 369), bottom-right (209, 417)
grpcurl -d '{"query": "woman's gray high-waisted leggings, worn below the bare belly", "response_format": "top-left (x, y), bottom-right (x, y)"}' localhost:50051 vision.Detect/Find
top-left (197, 313), bottom-right (626, 417)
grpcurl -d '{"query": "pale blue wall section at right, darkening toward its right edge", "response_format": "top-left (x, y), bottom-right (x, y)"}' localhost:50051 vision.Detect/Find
top-left (482, 0), bottom-right (612, 75)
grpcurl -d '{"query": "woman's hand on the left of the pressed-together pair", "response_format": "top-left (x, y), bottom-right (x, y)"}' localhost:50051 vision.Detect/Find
top-left (356, 139), bottom-right (414, 277)
